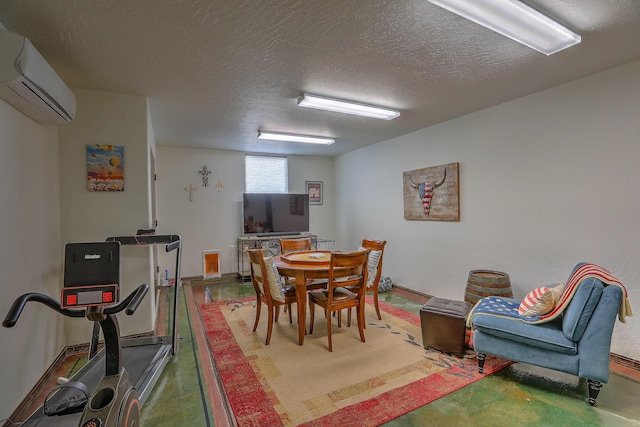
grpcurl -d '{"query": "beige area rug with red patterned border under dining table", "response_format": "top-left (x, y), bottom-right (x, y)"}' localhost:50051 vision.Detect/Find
top-left (199, 298), bottom-right (510, 427)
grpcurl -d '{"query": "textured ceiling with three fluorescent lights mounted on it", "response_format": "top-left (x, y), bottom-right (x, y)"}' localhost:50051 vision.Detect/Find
top-left (0, 0), bottom-right (640, 156)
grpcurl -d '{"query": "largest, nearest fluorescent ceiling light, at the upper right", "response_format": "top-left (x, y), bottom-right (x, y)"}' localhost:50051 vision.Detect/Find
top-left (428, 0), bottom-right (581, 55)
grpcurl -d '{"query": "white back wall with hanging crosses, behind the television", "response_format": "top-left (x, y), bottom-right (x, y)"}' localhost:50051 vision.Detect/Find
top-left (157, 146), bottom-right (335, 277)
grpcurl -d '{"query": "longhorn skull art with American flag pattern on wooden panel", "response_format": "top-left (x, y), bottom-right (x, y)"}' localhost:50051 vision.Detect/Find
top-left (402, 163), bottom-right (460, 221)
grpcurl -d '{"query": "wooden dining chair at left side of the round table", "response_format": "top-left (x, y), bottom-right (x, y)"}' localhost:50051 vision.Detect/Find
top-left (247, 249), bottom-right (298, 345)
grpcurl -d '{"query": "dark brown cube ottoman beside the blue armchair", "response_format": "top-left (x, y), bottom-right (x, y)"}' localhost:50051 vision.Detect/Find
top-left (420, 297), bottom-right (471, 356)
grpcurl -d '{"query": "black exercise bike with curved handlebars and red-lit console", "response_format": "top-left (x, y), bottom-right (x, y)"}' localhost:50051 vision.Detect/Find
top-left (2, 242), bottom-right (149, 427)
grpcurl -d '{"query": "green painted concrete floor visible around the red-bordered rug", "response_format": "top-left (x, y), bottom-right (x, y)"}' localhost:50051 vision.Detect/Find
top-left (135, 279), bottom-right (640, 427)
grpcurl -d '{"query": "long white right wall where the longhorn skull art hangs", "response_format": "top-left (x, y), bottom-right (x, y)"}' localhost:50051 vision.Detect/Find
top-left (335, 62), bottom-right (640, 360)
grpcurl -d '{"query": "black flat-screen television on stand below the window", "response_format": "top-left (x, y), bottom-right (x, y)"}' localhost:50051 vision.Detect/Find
top-left (242, 193), bottom-right (309, 235)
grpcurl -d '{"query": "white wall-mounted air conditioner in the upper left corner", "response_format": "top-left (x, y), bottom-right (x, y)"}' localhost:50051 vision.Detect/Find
top-left (0, 29), bottom-right (76, 125)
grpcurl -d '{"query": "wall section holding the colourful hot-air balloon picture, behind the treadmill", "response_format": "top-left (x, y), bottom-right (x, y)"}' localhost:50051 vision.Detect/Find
top-left (59, 88), bottom-right (155, 343)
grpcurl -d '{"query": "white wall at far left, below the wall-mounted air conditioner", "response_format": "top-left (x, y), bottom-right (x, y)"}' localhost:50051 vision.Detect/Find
top-left (0, 99), bottom-right (64, 419)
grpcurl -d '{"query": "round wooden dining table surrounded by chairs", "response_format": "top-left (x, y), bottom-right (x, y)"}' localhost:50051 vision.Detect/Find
top-left (273, 251), bottom-right (331, 345)
